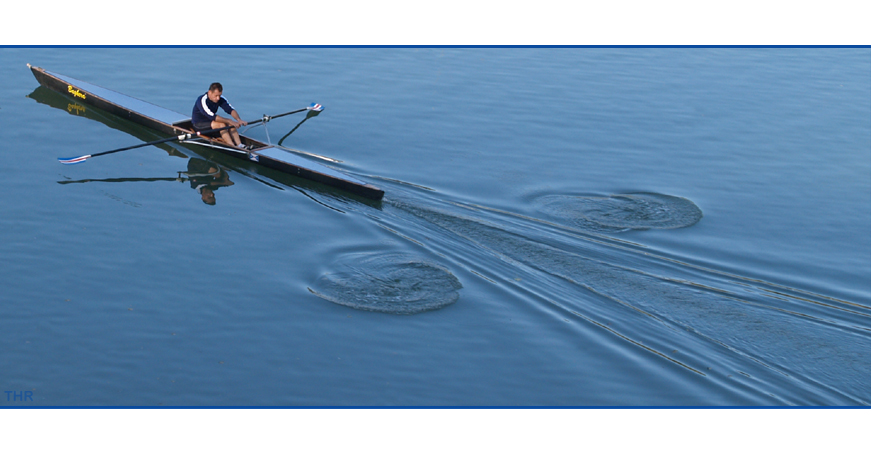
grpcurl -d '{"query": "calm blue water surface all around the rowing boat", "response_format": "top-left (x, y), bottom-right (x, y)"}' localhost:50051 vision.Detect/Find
top-left (0, 48), bottom-right (871, 406)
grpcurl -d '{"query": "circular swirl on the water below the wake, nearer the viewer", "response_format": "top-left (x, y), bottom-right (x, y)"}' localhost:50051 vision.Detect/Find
top-left (309, 254), bottom-right (463, 315)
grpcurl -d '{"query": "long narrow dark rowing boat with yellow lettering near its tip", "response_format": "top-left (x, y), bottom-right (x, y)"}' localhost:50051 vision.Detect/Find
top-left (27, 64), bottom-right (384, 200)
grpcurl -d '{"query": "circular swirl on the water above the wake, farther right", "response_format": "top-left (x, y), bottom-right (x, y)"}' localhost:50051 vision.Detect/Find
top-left (539, 193), bottom-right (702, 231)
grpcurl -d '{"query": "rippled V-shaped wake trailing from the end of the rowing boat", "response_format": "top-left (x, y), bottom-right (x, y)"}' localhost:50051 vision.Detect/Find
top-left (381, 188), bottom-right (871, 402)
